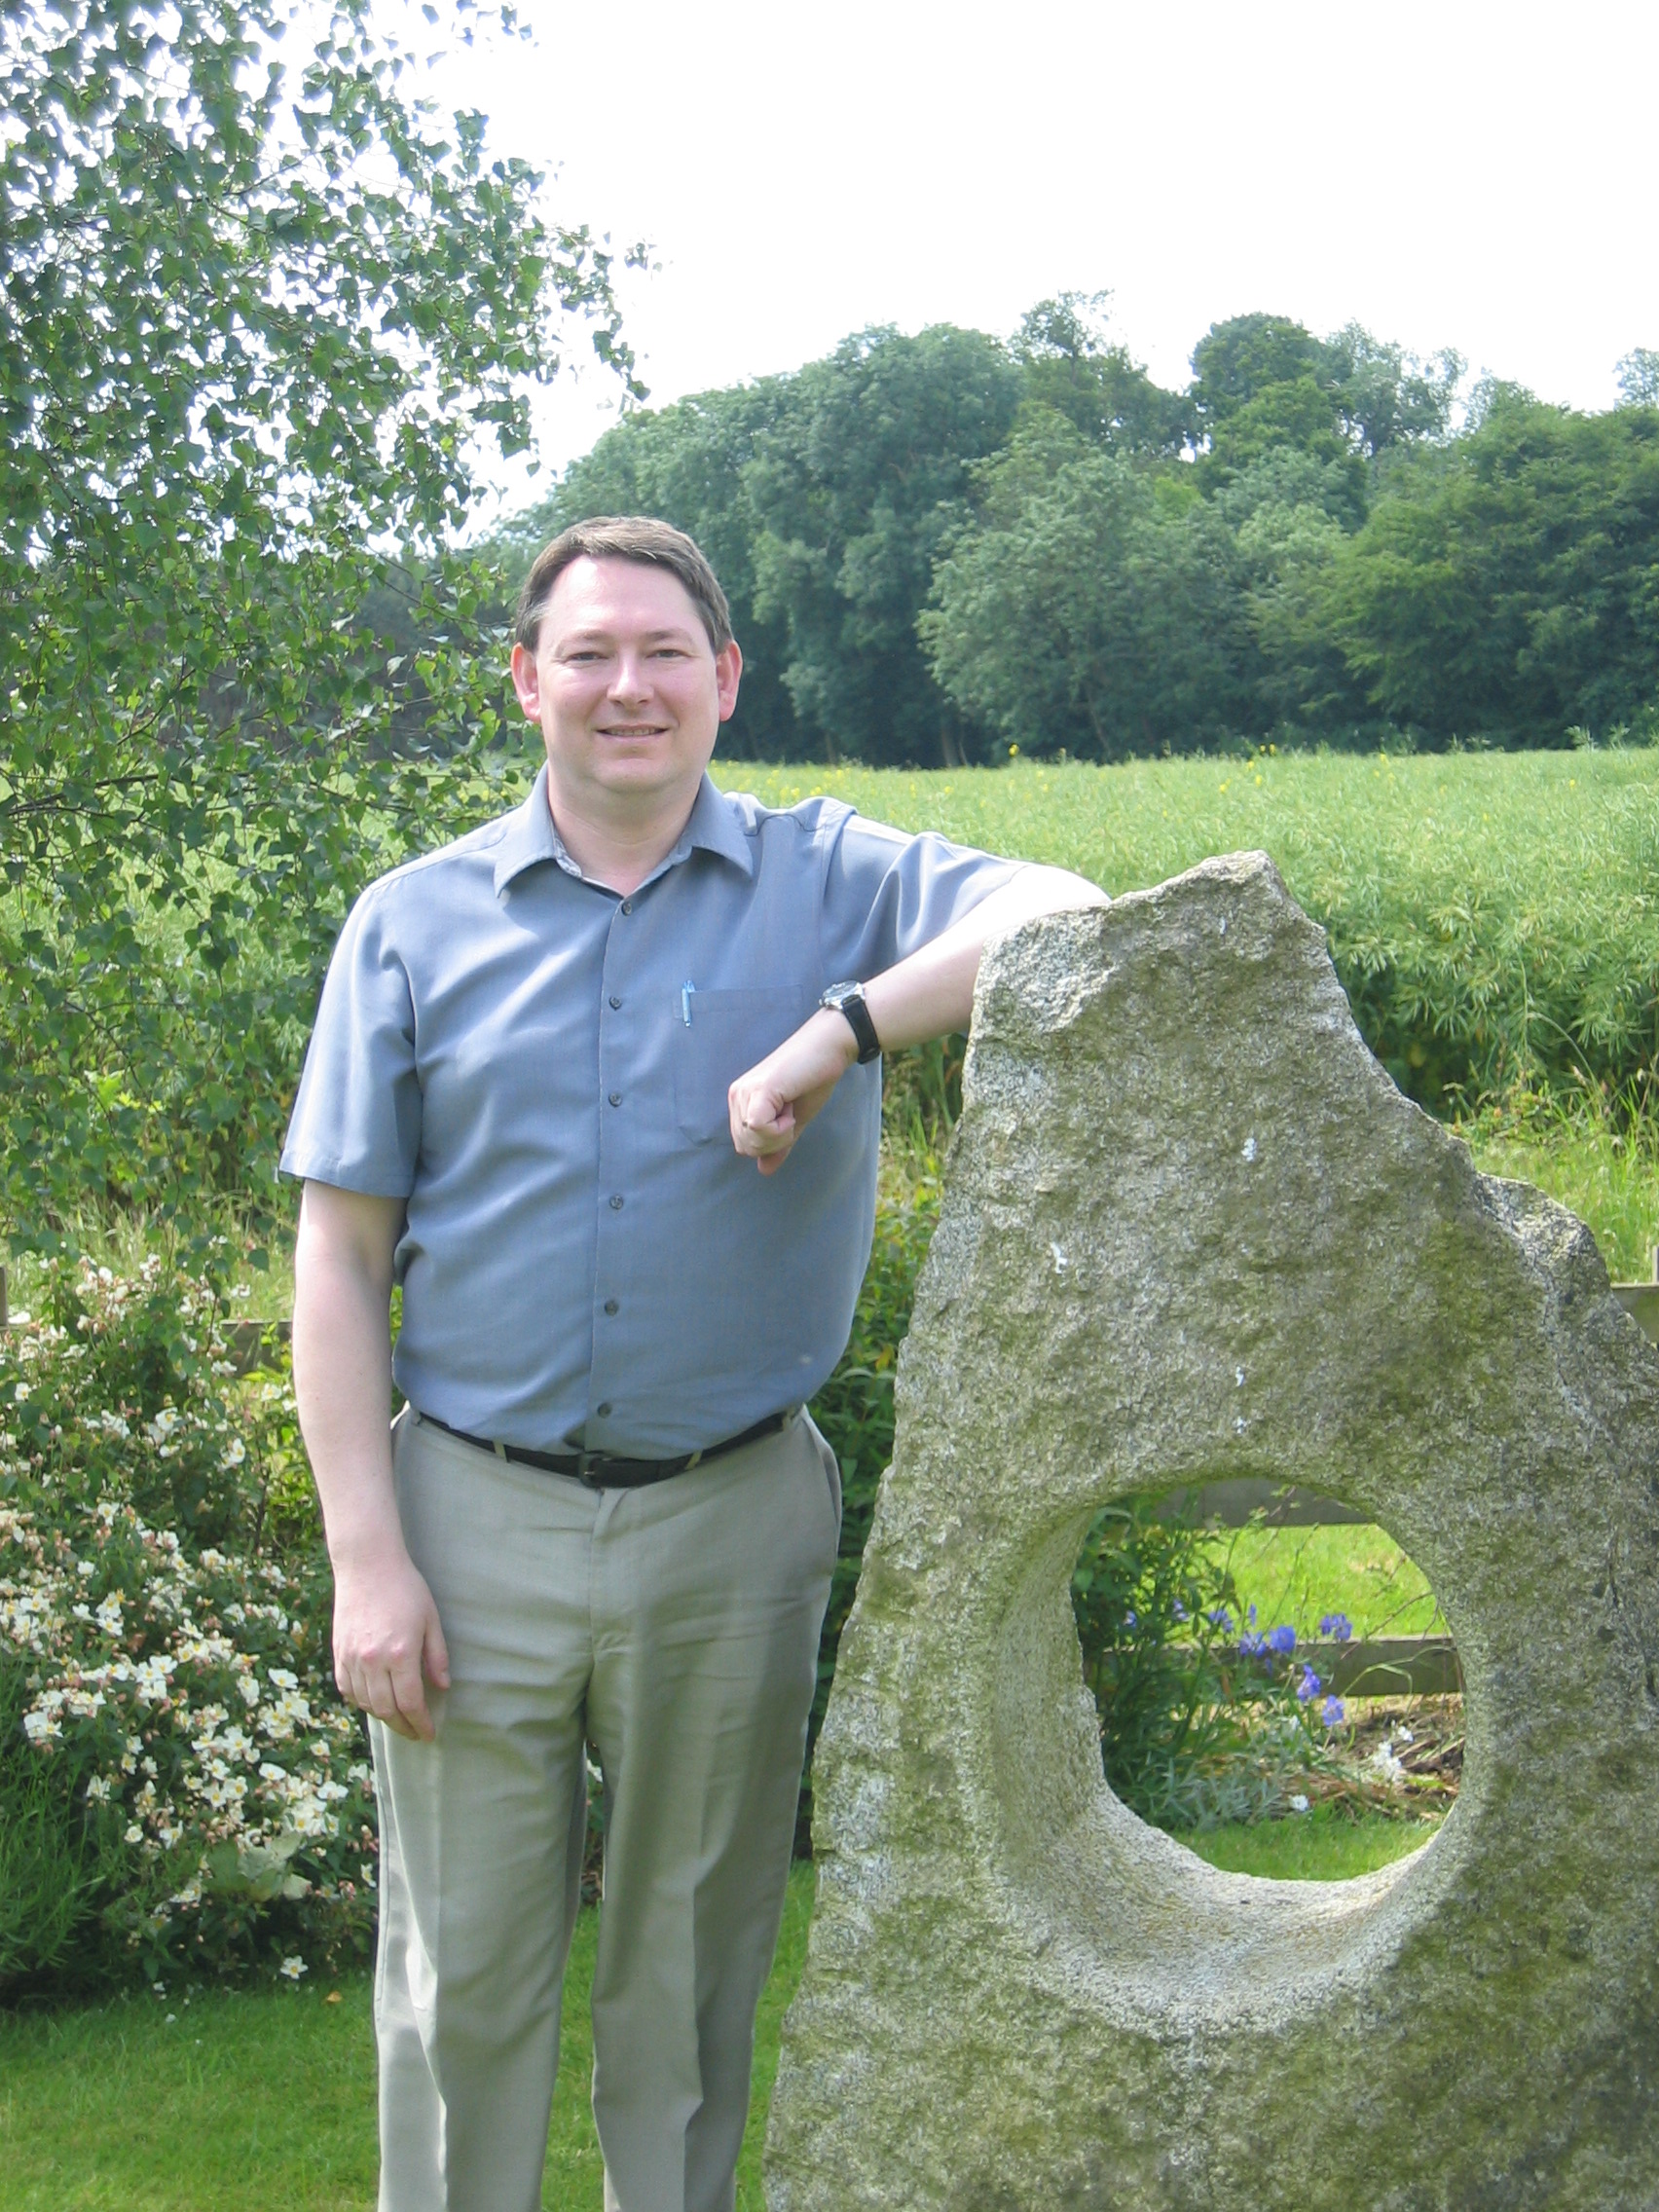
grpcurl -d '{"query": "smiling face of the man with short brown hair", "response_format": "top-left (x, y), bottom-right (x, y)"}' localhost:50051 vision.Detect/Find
top-left (513, 555), bottom-right (743, 814)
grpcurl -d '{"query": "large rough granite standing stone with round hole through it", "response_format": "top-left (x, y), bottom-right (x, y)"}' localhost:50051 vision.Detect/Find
top-left (765, 854), bottom-right (1659, 2212)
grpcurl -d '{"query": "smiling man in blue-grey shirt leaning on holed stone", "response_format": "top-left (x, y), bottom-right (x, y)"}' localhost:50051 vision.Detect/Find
top-left (283, 518), bottom-right (1099, 2212)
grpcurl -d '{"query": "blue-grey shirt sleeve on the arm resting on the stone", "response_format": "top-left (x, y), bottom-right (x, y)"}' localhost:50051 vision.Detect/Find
top-left (823, 814), bottom-right (1019, 982)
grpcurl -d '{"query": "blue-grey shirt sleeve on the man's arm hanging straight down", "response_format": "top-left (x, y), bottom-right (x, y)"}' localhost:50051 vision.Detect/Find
top-left (281, 887), bottom-right (421, 1198)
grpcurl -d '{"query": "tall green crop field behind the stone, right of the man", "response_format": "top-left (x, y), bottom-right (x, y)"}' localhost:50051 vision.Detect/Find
top-left (719, 752), bottom-right (1659, 1113)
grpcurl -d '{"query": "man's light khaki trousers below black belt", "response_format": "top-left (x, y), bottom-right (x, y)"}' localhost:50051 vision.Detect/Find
top-left (372, 1412), bottom-right (840, 2212)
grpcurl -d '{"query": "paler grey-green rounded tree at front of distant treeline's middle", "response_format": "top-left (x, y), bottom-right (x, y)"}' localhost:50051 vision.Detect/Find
top-left (920, 416), bottom-right (1256, 761)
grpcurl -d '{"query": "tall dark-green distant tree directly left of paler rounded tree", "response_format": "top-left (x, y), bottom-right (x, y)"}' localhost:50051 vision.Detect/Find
top-left (743, 325), bottom-right (1019, 763)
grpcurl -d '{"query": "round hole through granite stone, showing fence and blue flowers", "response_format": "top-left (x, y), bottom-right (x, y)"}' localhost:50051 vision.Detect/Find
top-left (1071, 1482), bottom-right (1462, 1880)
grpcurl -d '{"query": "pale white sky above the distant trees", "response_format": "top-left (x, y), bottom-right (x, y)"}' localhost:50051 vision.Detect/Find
top-left (418, 0), bottom-right (1659, 504)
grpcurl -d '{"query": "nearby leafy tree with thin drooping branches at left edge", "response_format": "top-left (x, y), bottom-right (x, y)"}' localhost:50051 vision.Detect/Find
top-left (0, 0), bottom-right (631, 1243)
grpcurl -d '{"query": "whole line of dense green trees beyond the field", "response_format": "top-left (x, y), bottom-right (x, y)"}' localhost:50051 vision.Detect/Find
top-left (496, 294), bottom-right (1659, 765)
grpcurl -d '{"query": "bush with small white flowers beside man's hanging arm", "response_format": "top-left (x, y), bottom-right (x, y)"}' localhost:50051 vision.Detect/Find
top-left (0, 1261), bottom-right (376, 1991)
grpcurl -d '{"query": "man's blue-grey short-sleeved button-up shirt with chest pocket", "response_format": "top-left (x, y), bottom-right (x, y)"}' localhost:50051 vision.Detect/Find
top-left (283, 770), bottom-right (1015, 1457)
